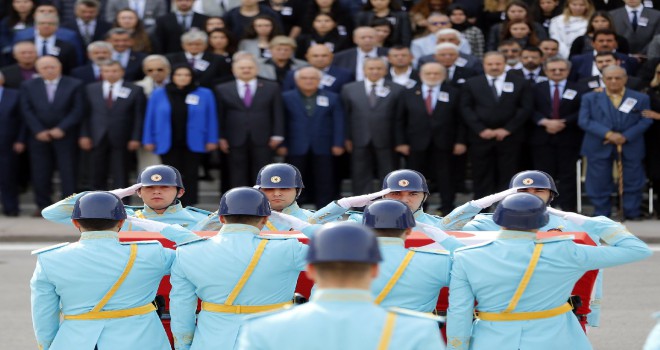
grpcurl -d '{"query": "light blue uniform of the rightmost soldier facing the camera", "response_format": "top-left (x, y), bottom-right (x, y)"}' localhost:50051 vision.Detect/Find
top-left (446, 202), bottom-right (619, 327)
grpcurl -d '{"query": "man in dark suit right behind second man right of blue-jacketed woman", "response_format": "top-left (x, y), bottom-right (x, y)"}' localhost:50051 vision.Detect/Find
top-left (282, 44), bottom-right (355, 94)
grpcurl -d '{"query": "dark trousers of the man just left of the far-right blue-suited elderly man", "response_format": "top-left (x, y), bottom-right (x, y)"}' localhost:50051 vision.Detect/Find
top-left (532, 143), bottom-right (580, 212)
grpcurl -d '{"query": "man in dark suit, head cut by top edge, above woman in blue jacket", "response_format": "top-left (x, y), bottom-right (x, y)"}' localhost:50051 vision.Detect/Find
top-left (154, 0), bottom-right (208, 54)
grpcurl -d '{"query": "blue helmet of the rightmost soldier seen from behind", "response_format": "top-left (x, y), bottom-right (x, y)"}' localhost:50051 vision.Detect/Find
top-left (493, 193), bottom-right (550, 230)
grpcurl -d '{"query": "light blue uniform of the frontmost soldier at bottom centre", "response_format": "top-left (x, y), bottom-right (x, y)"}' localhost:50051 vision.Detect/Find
top-left (238, 289), bottom-right (445, 350)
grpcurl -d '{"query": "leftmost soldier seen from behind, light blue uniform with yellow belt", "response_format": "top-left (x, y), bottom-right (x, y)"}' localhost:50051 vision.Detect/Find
top-left (30, 192), bottom-right (182, 350)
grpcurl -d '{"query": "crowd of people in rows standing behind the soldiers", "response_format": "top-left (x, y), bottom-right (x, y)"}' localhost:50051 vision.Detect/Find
top-left (0, 0), bottom-right (660, 220)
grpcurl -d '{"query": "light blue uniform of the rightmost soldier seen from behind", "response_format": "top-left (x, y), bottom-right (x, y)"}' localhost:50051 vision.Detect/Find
top-left (447, 225), bottom-right (651, 350)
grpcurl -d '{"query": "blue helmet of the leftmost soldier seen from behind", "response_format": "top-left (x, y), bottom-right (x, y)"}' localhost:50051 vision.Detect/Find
top-left (71, 191), bottom-right (126, 220)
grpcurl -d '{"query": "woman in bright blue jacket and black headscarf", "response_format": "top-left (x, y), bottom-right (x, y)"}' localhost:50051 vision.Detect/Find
top-left (142, 65), bottom-right (218, 205)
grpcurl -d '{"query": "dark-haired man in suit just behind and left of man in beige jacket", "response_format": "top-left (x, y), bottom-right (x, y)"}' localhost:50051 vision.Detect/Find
top-left (106, 28), bottom-right (147, 81)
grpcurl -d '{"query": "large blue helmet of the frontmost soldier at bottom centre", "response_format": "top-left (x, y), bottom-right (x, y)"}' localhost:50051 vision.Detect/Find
top-left (307, 221), bottom-right (383, 264)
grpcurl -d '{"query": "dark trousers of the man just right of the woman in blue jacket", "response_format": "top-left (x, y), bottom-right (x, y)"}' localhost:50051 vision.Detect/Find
top-left (227, 141), bottom-right (273, 188)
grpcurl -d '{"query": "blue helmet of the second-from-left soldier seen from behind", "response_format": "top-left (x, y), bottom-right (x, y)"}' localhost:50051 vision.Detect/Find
top-left (218, 187), bottom-right (270, 216)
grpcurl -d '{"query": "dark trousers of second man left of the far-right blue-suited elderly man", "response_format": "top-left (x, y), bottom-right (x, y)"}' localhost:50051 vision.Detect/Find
top-left (468, 133), bottom-right (522, 198)
